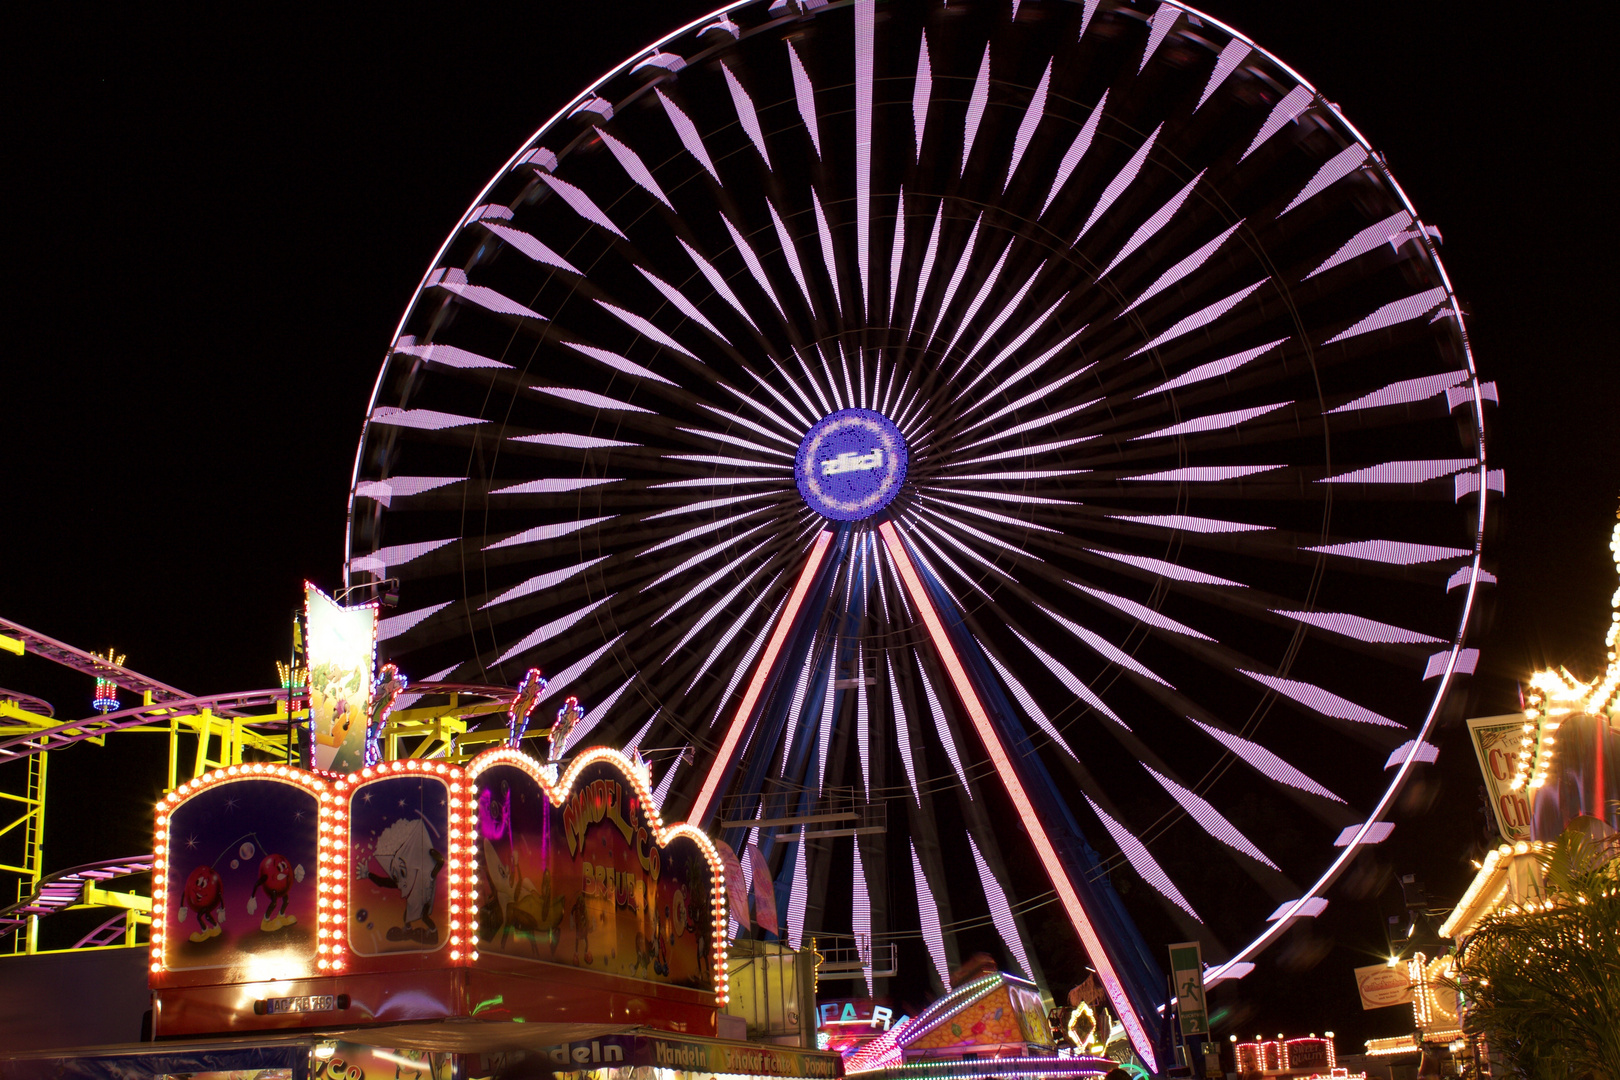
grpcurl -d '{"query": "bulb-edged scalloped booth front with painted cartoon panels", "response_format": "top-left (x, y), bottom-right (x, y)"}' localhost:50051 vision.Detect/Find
top-left (149, 746), bottom-right (729, 1036)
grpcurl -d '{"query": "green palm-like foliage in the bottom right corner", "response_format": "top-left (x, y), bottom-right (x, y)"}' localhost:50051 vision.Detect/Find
top-left (1452, 826), bottom-right (1620, 1080)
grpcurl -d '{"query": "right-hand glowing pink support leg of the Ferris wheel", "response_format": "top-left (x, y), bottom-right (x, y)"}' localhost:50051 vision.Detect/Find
top-left (878, 521), bottom-right (1160, 1072)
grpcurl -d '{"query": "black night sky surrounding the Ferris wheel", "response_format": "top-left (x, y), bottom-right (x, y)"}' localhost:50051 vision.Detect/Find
top-left (0, 0), bottom-right (1620, 1051)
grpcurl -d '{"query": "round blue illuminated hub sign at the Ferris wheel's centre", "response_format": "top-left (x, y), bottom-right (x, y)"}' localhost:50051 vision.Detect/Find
top-left (794, 408), bottom-right (906, 521)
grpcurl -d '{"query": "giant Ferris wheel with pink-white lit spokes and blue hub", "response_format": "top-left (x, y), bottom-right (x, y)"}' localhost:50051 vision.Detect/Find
top-left (347, 0), bottom-right (1502, 1056)
